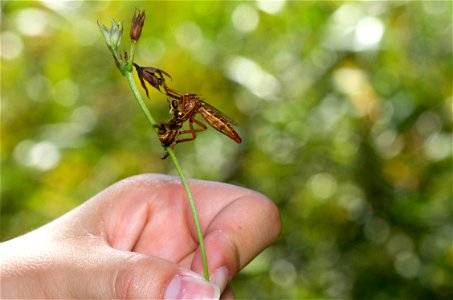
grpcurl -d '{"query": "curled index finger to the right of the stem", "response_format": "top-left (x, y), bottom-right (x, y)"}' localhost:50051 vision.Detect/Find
top-left (186, 181), bottom-right (281, 287)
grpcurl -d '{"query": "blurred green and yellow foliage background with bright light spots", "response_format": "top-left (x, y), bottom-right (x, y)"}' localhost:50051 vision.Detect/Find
top-left (1, 0), bottom-right (453, 299)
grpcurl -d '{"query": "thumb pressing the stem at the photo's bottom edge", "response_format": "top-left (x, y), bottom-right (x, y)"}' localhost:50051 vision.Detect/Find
top-left (69, 249), bottom-right (220, 299)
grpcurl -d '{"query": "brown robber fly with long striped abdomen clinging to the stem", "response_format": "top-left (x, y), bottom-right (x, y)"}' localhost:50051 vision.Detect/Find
top-left (165, 87), bottom-right (242, 144)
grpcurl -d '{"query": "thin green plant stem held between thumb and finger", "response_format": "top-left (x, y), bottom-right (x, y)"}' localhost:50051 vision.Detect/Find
top-left (124, 70), bottom-right (209, 280)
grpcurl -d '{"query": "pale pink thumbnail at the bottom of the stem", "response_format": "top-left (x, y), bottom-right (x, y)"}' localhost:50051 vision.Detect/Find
top-left (164, 274), bottom-right (220, 299)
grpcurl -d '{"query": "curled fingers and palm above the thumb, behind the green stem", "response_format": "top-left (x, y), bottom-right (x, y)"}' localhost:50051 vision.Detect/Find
top-left (55, 175), bottom-right (281, 296)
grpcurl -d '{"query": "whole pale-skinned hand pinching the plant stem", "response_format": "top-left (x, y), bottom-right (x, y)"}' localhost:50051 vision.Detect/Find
top-left (0, 174), bottom-right (280, 299)
